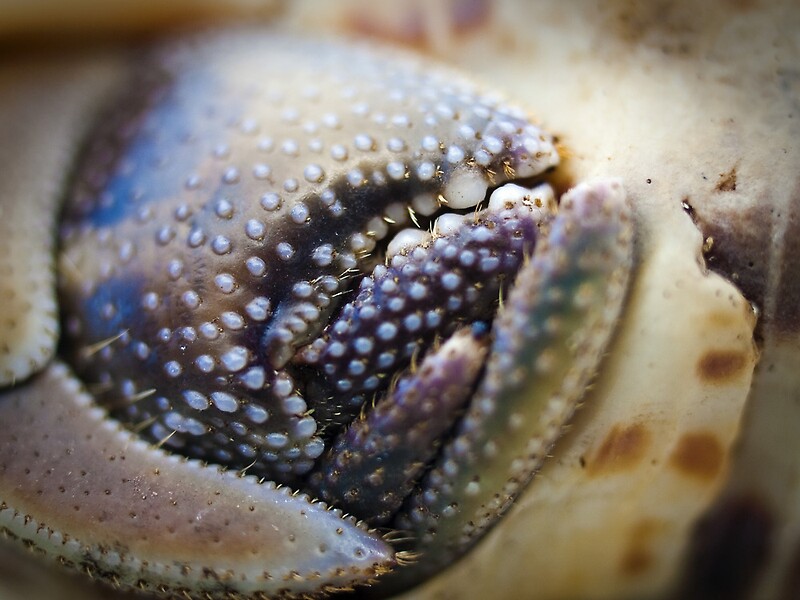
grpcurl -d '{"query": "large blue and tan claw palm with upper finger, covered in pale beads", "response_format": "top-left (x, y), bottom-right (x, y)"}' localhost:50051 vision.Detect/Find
top-left (60, 32), bottom-right (558, 483)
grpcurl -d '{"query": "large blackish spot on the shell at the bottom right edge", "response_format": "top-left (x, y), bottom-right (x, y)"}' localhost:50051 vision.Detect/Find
top-left (676, 493), bottom-right (775, 600)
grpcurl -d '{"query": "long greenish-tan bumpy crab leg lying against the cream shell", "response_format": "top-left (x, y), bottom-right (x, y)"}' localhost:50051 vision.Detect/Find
top-left (390, 181), bottom-right (632, 583)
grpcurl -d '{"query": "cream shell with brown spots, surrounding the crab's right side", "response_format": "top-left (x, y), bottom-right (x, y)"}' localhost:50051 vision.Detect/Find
top-left (0, 0), bottom-right (800, 598)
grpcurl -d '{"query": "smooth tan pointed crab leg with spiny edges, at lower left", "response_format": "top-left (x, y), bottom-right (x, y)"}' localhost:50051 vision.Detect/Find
top-left (0, 364), bottom-right (393, 598)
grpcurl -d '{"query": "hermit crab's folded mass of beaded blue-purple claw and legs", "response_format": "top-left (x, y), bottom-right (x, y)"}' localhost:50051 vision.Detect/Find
top-left (0, 24), bottom-right (630, 599)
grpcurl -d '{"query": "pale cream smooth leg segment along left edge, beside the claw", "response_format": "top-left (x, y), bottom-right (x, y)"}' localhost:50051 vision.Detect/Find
top-left (0, 57), bottom-right (126, 385)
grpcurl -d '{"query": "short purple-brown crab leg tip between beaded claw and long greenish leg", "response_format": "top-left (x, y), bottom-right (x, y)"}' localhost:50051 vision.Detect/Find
top-left (308, 327), bottom-right (487, 525)
